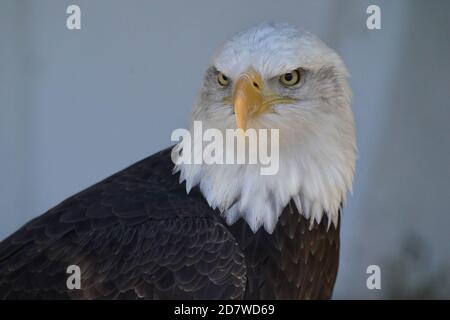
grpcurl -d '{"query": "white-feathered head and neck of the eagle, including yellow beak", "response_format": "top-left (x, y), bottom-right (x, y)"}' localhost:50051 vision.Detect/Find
top-left (174, 23), bottom-right (357, 233)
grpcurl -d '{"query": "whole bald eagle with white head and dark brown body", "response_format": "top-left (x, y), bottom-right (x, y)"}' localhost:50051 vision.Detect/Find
top-left (0, 23), bottom-right (356, 299)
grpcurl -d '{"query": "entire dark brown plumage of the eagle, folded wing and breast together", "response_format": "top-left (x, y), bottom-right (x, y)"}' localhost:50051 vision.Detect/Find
top-left (0, 149), bottom-right (339, 299)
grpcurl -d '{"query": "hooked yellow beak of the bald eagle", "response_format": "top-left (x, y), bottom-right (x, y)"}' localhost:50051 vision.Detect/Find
top-left (233, 71), bottom-right (265, 131)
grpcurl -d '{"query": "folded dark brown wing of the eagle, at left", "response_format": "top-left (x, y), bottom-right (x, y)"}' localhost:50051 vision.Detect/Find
top-left (0, 149), bottom-right (246, 299)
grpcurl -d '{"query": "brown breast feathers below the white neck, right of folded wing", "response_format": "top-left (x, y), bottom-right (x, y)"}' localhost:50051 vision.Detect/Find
top-left (230, 203), bottom-right (339, 299)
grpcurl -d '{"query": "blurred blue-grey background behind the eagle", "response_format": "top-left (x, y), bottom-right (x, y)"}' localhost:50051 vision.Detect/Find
top-left (0, 0), bottom-right (450, 299)
